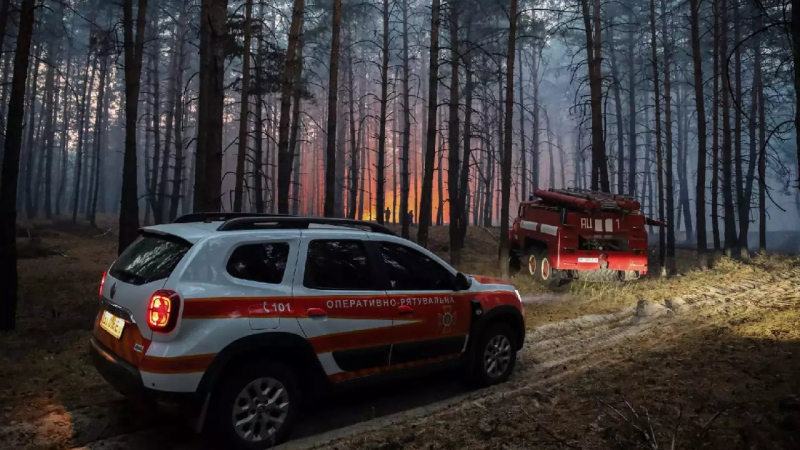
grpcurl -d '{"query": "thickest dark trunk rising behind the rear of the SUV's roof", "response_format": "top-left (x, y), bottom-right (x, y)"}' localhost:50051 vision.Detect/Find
top-left (194, 0), bottom-right (228, 212)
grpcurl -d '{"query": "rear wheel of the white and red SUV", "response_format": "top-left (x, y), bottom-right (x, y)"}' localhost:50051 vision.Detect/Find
top-left (214, 361), bottom-right (300, 450)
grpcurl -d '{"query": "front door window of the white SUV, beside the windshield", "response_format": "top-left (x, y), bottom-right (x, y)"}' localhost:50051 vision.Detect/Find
top-left (380, 242), bottom-right (453, 291)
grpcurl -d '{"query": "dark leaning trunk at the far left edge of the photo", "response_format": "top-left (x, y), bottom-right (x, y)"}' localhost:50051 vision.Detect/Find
top-left (0, 0), bottom-right (35, 331)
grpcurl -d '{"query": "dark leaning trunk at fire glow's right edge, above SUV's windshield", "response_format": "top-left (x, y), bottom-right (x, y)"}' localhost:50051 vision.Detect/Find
top-left (416, 0), bottom-right (441, 247)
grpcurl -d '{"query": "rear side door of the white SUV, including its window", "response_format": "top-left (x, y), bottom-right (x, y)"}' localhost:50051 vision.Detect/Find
top-left (293, 233), bottom-right (392, 381)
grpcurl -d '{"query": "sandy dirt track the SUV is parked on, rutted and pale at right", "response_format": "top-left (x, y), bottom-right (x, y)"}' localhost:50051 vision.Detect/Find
top-left (0, 268), bottom-right (800, 449)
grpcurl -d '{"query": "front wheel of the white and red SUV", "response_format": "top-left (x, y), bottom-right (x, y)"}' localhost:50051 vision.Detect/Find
top-left (472, 322), bottom-right (517, 386)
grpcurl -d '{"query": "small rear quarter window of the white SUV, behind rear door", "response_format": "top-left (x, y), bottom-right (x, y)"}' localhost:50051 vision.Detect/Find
top-left (226, 242), bottom-right (289, 284)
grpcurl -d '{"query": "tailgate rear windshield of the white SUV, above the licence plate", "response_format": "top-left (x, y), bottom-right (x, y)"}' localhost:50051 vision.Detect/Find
top-left (109, 234), bottom-right (192, 285)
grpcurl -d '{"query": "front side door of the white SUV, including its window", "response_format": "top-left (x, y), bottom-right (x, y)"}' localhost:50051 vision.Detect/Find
top-left (375, 241), bottom-right (470, 365)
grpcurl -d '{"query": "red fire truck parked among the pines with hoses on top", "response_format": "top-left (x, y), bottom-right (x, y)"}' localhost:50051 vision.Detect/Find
top-left (509, 189), bottom-right (661, 286)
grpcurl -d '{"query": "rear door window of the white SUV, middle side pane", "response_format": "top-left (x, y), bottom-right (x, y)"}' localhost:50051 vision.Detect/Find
top-left (303, 240), bottom-right (375, 290)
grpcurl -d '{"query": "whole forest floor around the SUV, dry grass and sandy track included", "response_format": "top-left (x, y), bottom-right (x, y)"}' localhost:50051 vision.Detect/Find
top-left (0, 222), bottom-right (800, 449)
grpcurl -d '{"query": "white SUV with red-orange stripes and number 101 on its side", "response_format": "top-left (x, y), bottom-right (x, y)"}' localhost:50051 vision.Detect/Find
top-left (90, 213), bottom-right (525, 449)
